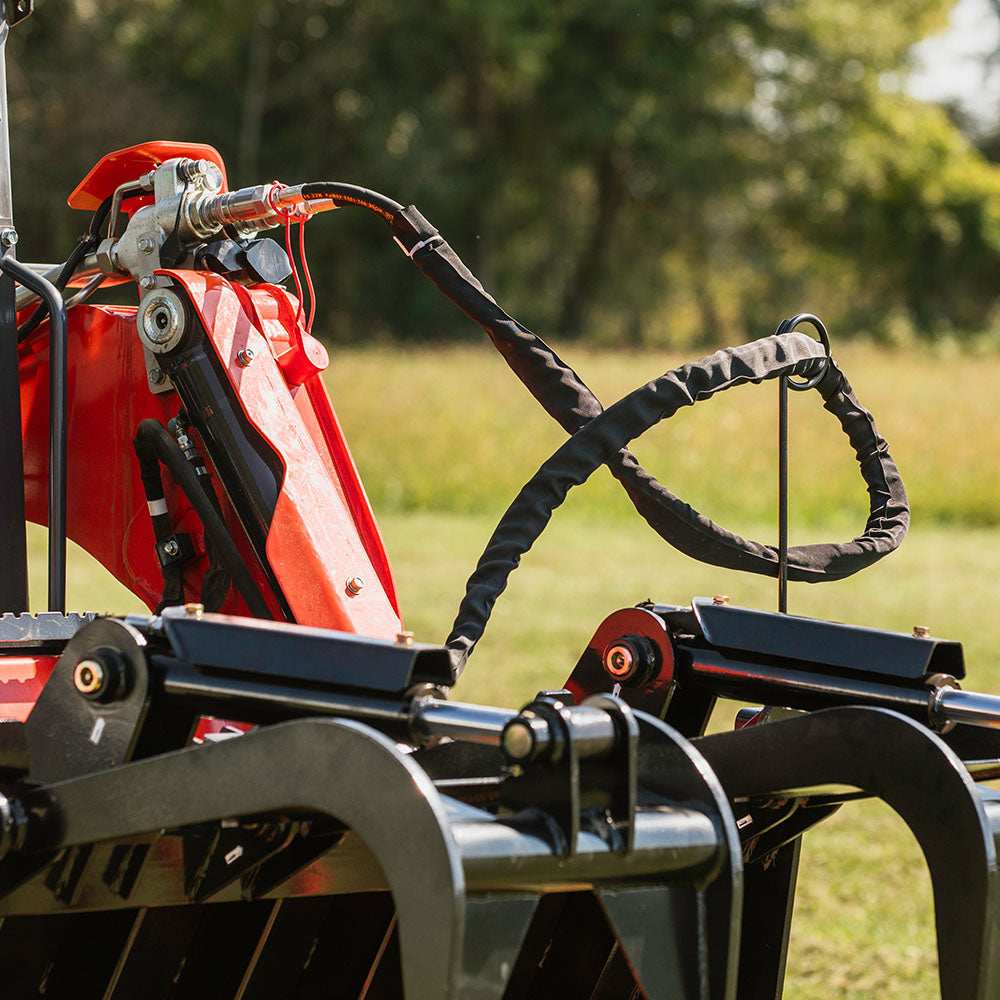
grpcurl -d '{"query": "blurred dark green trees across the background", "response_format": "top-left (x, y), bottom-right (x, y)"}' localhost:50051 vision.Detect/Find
top-left (9, 0), bottom-right (1000, 343)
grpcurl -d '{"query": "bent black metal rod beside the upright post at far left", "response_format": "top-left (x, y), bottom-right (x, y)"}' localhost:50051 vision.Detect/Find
top-left (0, 256), bottom-right (68, 614)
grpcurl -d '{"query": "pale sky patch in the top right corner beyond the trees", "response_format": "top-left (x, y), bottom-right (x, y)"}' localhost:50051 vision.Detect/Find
top-left (907, 0), bottom-right (1000, 132)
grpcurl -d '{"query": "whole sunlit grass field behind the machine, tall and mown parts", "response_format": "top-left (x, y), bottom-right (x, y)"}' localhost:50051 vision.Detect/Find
top-left (23, 346), bottom-right (1000, 1000)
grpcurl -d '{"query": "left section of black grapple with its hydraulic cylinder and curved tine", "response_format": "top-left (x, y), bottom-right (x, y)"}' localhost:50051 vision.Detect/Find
top-left (0, 612), bottom-right (741, 1000)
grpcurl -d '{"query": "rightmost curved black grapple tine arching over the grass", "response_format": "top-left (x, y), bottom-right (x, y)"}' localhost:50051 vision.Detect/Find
top-left (697, 708), bottom-right (1000, 1000)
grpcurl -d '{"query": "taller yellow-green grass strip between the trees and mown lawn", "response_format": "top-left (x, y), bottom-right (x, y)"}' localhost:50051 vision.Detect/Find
top-left (327, 344), bottom-right (1000, 540)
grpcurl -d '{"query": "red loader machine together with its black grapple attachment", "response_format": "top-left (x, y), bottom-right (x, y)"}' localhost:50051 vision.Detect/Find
top-left (0, 0), bottom-right (1000, 1000)
